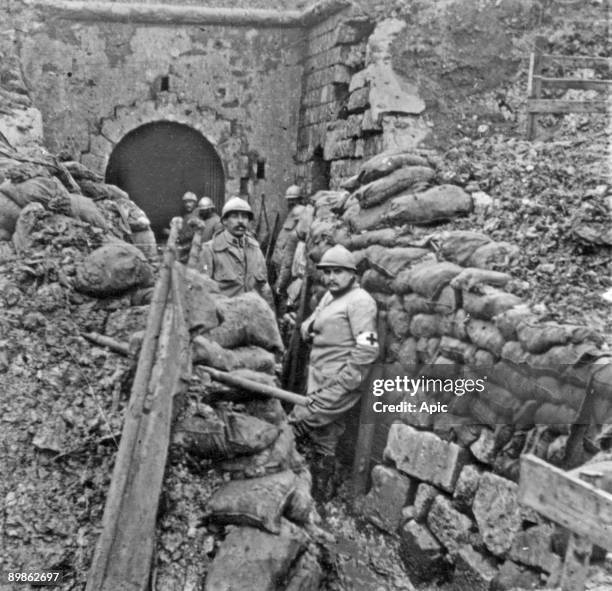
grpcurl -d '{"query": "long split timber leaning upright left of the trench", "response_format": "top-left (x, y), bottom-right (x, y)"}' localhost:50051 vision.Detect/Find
top-left (86, 218), bottom-right (191, 591)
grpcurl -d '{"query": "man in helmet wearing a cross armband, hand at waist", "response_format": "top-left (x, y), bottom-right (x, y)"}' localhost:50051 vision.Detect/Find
top-left (289, 245), bottom-right (378, 501)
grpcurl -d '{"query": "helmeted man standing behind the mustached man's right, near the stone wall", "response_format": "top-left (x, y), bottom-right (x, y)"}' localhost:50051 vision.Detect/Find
top-left (271, 185), bottom-right (304, 298)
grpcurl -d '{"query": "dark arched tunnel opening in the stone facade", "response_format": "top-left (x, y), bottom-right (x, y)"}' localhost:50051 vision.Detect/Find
top-left (106, 121), bottom-right (225, 238)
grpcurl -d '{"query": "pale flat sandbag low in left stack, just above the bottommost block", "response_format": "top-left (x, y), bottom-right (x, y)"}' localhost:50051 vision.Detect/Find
top-left (206, 470), bottom-right (296, 533)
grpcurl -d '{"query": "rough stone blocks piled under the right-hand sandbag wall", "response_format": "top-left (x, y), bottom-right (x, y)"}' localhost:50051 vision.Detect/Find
top-left (364, 423), bottom-right (562, 591)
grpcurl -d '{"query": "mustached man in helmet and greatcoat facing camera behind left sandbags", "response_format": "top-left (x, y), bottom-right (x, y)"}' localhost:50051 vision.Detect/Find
top-left (200, 197), bottom-right (274, 309)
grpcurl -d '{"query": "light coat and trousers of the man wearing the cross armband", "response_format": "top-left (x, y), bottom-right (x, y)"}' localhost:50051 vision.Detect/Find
top-left (290, 284), bottom-right (378, 456)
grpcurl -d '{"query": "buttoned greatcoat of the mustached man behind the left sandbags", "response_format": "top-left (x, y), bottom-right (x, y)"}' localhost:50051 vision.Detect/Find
top-left (200, 230), bottom-right (273, 306)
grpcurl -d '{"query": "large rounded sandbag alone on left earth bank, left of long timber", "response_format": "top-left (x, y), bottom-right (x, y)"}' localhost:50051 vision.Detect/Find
top-left (75, 241), bottom-right (153, 297)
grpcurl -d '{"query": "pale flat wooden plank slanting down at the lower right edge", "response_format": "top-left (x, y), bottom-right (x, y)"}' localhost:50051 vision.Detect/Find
top-left (518, 454), bottom-right (612, 551)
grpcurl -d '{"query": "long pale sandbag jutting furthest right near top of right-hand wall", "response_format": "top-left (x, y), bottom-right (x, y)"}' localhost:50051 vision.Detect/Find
top-left (388, 185), bottom-right (474, 227)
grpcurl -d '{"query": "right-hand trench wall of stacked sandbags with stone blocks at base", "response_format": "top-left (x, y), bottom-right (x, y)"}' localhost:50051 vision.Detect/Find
top-left (296, 151), bottom-right (612, 589)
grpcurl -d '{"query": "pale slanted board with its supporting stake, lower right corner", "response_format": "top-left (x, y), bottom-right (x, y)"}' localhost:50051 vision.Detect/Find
top-left (519, 454), bottom-right (612, 591)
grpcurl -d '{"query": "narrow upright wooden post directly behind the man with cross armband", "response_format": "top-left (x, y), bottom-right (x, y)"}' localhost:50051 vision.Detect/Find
top-left (353, 312), bottom-right (387, 498)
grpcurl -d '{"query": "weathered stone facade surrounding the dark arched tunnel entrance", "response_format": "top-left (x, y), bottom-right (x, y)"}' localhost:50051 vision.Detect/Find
top-left (8, 1), bottom-right (302, 219)
